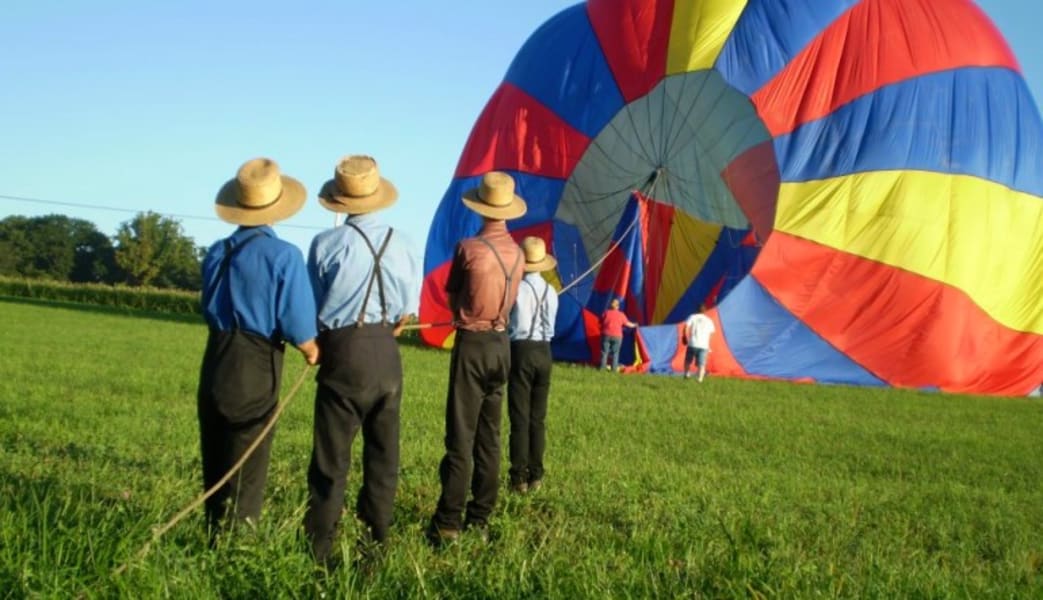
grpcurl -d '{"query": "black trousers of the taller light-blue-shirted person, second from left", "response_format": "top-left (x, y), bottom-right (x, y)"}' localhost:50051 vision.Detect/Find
top-left (305, 325), bottom-right (402, 560)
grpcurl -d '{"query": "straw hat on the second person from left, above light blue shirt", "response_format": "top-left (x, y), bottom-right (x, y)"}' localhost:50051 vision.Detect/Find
top-left (319, 154), bottom-right (398, 215)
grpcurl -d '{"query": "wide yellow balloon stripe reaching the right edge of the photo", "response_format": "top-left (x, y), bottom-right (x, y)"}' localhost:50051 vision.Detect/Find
top-left (776, 171), bottom-right (1043, 334)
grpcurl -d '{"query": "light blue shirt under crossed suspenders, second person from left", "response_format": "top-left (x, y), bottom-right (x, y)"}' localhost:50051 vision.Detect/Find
top-left (308, 214), bottom-right (420, 330)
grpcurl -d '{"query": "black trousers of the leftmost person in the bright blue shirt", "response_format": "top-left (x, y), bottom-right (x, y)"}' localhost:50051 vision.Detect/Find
top-left (196, 330), bottom-right (283, 530)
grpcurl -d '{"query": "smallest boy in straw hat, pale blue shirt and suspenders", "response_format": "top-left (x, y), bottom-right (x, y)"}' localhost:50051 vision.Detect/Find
top-left (507, 237), bottom-right (558, 494)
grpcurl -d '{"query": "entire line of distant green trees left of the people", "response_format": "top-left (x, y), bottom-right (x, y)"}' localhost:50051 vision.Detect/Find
top-left (0, 212), bottom-right (205, 291)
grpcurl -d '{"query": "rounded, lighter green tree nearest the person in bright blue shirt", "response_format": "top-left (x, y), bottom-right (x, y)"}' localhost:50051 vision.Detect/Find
top-left (115, 212), bottom-right (201, 290)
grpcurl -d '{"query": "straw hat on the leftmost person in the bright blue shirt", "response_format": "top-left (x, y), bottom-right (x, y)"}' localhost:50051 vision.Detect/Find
top-left (214, 159), bottom-right (308, 226)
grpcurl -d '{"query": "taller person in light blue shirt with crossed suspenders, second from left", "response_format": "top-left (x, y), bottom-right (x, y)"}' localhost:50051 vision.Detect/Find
top-left (305, 155), bottom-right (420, 567)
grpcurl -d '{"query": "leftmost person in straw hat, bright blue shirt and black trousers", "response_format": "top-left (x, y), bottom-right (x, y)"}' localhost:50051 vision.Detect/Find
top-left (198, 159), bottom-right (319, 541)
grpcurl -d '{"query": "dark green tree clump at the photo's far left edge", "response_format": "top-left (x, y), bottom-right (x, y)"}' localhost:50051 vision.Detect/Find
top-left (0, 215), bottom-right (115, 283)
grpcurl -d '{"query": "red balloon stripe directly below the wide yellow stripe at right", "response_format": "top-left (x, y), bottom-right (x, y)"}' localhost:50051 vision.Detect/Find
top-left (753, 232), bottom-right (1043, 395)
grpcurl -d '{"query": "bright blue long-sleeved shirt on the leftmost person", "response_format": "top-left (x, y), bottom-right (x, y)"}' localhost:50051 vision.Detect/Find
top-left (201, 226), bottom-right (316, 344)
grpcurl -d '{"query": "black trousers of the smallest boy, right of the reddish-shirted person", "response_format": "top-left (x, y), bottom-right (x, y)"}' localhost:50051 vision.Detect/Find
top-left (507, 340), bottom-right (554, 484)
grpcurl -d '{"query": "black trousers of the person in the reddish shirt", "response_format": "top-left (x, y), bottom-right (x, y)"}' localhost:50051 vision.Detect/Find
top-left (432, 330), bottom-right (511, 529)
